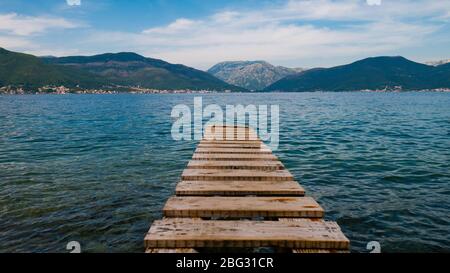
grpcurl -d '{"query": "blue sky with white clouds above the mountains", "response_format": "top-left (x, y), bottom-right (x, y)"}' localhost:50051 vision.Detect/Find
top-left (0, 0), bottom-right (450, 70)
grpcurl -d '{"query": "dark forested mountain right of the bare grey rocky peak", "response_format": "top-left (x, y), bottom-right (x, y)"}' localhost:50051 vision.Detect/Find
top-left (265, 57), bottom-right (450, 92)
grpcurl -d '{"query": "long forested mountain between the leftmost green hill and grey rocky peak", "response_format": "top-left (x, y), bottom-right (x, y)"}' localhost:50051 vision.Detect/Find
top-left (43, 52), bottom-right (243, 91)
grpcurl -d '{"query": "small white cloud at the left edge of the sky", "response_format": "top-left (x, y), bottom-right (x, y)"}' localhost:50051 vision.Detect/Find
top-left (0, 13), bottom-right (78, 36)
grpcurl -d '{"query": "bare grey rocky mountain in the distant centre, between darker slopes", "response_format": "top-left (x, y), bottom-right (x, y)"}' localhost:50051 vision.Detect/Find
top-left (208, 61), bottom-right (302, 90)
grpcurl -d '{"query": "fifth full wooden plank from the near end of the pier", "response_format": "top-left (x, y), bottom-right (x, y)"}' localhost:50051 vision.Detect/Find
top-left (187, 160), bottom-right (284, 170)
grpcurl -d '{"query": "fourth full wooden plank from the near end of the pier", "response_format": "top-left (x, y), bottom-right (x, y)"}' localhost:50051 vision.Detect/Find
top-left (181, 169), bottom-right (294, 181)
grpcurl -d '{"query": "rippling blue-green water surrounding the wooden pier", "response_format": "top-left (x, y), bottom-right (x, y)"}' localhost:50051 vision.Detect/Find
top-left (0, 92), bottom-right (450, 252)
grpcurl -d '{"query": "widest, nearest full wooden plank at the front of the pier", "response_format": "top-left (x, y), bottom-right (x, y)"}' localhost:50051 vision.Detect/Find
top-left (145, 218), bottom-right (350, 250)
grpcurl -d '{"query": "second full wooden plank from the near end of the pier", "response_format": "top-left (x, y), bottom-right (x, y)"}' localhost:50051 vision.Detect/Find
top-left (163, 196), bottom-right (324, 218)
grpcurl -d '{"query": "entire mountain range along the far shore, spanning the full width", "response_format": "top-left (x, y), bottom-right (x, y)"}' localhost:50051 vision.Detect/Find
top-left (0, 48), bottom-right (450, 92)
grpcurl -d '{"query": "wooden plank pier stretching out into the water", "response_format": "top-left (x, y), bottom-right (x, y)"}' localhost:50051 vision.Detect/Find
top-left (145, 126), bottom-right (350, 253)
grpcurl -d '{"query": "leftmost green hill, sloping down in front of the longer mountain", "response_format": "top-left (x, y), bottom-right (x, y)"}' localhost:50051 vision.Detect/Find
top-left (0, 48), bottom-right (107, 89)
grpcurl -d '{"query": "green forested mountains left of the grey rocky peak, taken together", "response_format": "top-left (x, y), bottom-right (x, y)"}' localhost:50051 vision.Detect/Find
top-left (0, 48), bottom-right (245, 91)
